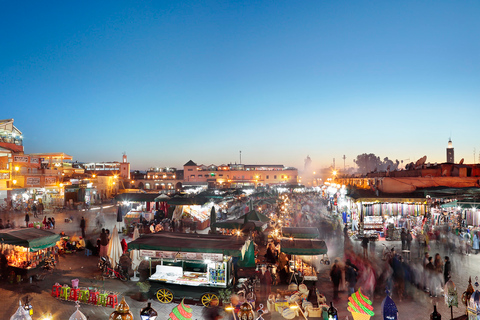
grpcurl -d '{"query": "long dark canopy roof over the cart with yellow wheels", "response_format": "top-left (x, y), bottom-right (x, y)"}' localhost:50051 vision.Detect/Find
top-left (128, 232), bottom-right (245, 257)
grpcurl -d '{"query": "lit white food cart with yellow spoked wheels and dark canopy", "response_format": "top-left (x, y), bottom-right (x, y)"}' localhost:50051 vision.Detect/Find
top-left (128, 232), bottom-right (250, 306)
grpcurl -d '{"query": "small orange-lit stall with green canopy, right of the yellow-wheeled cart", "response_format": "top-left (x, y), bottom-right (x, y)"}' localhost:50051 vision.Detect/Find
top-left (280, 238), bottom-right (328, 282)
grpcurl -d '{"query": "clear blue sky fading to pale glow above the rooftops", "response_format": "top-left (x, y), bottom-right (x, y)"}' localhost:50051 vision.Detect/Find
top-left (0, 1), bottom-right (480, 169)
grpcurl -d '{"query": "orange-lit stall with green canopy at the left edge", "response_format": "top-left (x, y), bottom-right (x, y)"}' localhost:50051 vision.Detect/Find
top-left (0, 228), bottom-right (60, 278)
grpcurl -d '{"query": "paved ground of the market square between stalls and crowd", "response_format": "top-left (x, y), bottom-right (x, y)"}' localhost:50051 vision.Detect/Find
top-left (0, 208), bottom-right (480, 320)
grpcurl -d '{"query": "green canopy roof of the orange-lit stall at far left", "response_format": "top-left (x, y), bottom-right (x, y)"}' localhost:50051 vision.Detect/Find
top-left (0, 228), bottom-right (60, 251)
